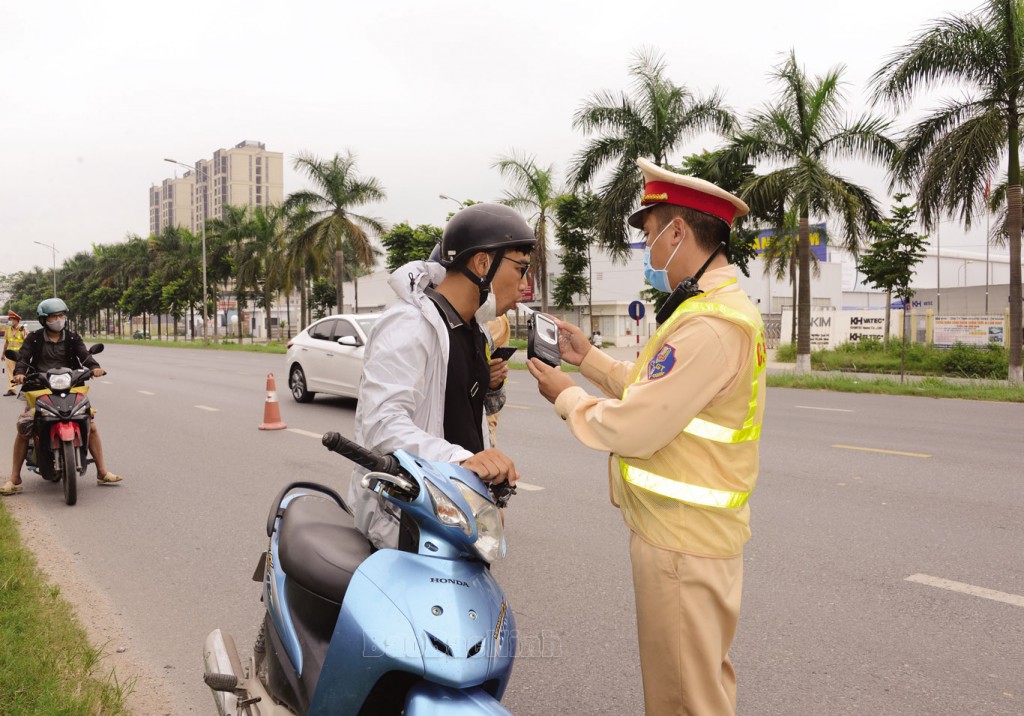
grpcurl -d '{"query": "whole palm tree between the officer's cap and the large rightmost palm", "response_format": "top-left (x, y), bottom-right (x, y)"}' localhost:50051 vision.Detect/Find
top-left (723, 51), bottom-right (896, 371)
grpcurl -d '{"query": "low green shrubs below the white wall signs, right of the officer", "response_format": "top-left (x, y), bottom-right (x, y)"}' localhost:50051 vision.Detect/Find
top-left (775, 340), bottom-right (1009, 380)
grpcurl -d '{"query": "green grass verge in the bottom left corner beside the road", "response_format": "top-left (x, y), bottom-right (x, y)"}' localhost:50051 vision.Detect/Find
top-left (0, 504), bottom-right (133, 716)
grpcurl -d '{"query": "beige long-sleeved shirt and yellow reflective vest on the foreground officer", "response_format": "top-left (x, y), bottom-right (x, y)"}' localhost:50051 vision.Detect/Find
top-left (555, 265), bottom-right (766, 556)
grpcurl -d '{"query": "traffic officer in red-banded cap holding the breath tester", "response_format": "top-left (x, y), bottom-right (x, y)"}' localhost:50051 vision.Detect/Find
top-left (529, 159), bottom-right (766, 716)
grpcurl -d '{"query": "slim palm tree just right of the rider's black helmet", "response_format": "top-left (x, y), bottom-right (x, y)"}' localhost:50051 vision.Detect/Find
top-left (492, 151), bottom-right (562, 312)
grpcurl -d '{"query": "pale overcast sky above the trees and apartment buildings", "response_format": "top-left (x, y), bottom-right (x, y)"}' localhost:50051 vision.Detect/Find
top-left (0, 0), bottom-right (984, 272)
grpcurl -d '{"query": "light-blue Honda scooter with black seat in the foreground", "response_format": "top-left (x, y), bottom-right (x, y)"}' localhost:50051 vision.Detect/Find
top-left (204, 432), bottom-right (516, 716)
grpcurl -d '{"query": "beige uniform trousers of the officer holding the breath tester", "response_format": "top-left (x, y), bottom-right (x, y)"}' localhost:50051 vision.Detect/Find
top-left (630, 534), bottom-right (743, 716)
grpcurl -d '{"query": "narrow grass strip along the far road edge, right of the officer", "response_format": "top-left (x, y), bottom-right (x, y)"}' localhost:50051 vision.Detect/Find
top-left (768, 374), bottom-right (1024, 403)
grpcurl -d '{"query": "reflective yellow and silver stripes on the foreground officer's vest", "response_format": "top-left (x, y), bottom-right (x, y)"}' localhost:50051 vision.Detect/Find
top-left (618, 279), bottom-right (765, 508)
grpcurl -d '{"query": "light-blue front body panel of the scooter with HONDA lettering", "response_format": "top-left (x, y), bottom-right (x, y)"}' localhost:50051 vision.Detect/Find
top-left (301, 549), bottom-right (516, 716)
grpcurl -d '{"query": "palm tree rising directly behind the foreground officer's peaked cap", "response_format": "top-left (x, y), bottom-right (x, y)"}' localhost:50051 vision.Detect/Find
top-left (569, 50), bottom-right (735, 257)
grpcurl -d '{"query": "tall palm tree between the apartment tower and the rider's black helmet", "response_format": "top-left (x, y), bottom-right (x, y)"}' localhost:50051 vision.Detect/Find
top-left (285, 152), bottom-right (386, 311)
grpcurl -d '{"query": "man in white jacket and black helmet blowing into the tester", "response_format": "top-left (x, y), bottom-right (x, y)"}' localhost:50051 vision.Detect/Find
top-left (348, 204), bottom-right (537, 547)
